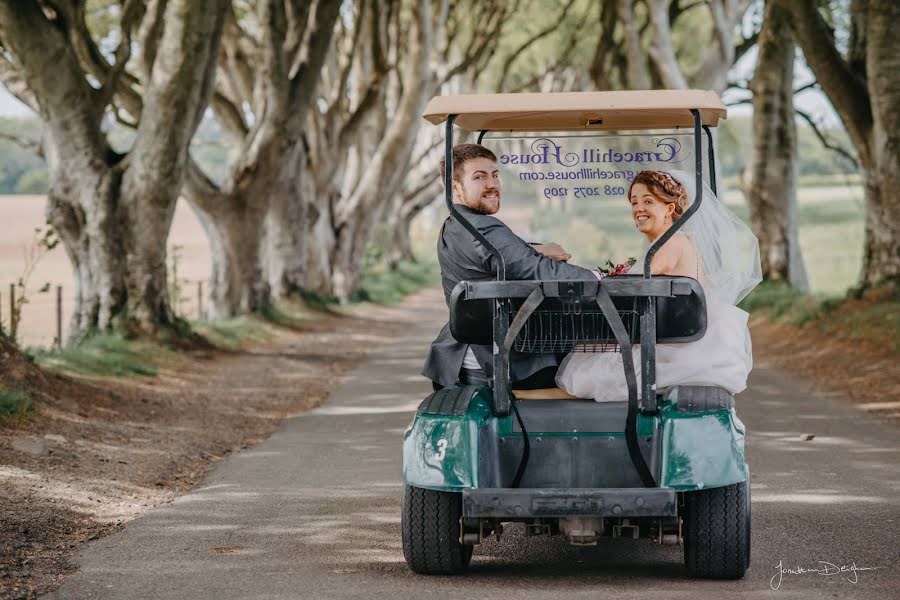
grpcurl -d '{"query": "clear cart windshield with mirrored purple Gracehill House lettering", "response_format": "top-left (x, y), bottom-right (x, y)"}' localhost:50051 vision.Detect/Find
top-left (482, 129), bottom-right (710, 267)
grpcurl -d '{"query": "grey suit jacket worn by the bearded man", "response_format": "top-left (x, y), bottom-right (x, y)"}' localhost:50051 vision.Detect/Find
top-left (422, 204), bottom-right (595, 386)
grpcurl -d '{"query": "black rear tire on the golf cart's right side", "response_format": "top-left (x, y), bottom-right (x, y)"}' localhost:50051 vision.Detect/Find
top-left (684, 482), bottom-right (750, 579)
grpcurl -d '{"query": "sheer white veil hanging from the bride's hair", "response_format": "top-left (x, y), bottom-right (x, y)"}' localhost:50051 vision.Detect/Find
top-left (652, 171), bottom-right (762, 304)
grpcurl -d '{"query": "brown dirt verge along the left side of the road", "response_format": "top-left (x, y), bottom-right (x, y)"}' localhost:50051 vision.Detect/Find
top-left (0, 289), bottom-right (443, 599)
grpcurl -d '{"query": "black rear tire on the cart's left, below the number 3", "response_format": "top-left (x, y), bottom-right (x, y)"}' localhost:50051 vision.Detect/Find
top-left (400, 485), bottom-right (472, 575)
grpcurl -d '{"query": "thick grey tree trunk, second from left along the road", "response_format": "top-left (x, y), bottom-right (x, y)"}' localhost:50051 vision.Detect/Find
top-left (185, 0), bottom-right (349, 316)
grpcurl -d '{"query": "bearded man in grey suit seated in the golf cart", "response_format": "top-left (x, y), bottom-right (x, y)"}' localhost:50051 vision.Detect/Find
top-left (422, 144), bottom-right (596, 389)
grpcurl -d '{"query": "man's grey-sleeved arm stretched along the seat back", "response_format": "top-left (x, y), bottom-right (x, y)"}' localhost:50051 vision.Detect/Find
top-left (477, 215), bottom-right (595, 280)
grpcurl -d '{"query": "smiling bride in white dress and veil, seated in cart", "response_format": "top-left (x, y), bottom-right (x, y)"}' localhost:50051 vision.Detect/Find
top-left (556, 171), bottom-right (762, 402)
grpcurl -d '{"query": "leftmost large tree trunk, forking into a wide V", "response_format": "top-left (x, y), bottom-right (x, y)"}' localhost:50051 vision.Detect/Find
top-left (0, 0), bottom-right (225, 334)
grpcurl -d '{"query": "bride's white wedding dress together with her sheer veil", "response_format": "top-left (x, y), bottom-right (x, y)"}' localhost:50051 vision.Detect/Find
top-left (556, 171), bottom-right (762, 402)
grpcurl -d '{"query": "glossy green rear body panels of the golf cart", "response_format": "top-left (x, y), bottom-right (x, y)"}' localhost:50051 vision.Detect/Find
top-left (403, 387), bottom-right (748, 492)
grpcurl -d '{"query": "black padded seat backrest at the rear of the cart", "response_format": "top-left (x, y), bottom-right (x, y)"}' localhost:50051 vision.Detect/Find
top-left (450, 276), bottom-right (706, 352)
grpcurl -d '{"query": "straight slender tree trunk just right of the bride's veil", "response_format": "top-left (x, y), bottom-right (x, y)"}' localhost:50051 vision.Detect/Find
top-left (741, 2), bottom-right (809, 291)
